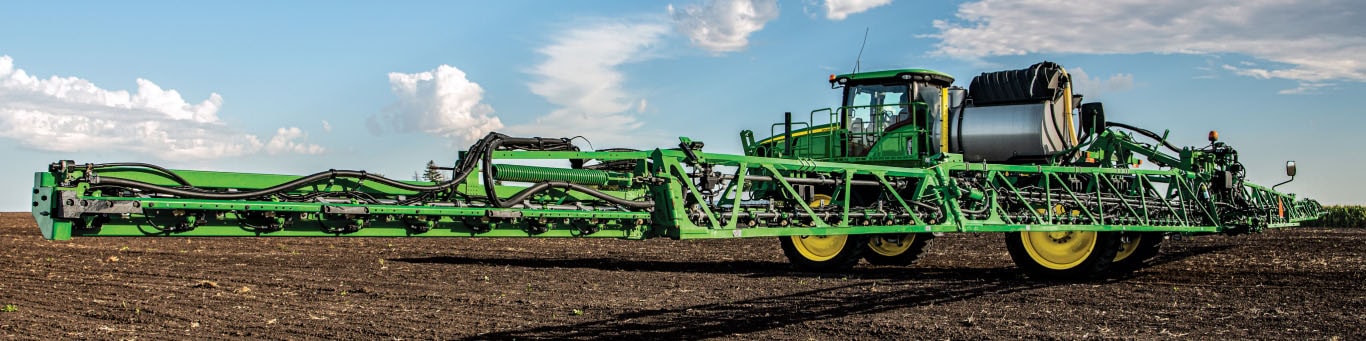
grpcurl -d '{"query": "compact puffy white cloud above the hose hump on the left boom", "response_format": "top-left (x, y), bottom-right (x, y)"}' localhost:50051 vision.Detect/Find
top-left (366, 64), bottom-right (503, 142)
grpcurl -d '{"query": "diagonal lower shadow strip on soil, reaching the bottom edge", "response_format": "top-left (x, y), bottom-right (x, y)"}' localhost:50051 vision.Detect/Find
top-left (470, 267), bottom-right (1052, 340)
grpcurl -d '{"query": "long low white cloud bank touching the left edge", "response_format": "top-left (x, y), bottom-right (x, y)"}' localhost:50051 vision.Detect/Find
top-left (0, 56), bottom-right (324, 160)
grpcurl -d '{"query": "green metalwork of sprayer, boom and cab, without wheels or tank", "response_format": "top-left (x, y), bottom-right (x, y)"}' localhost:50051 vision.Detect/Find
top-left (33, 70), bottom-right (1324, 240)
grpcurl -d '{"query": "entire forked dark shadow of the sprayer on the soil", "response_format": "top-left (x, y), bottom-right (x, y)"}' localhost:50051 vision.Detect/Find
top-left (392, 246), bottom-right (1251, 340)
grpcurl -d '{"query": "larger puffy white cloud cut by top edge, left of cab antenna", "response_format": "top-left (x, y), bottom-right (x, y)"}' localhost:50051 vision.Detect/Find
top-left (668, 0), bottom-right (779, 53)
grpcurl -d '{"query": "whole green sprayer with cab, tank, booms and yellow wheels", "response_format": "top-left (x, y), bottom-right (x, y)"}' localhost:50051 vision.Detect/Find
top-left (33, 63), bottom-right (1322, 276)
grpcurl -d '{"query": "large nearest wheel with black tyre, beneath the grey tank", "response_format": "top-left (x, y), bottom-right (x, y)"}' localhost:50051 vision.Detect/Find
top-left (1005, 231), bottom-right (1119, 280)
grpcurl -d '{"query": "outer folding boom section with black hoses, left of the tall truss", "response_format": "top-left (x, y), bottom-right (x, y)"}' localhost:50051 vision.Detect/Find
top-left (33, 134), bottom-right (653, 239)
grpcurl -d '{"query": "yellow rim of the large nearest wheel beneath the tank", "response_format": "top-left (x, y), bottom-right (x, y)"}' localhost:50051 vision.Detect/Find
top-left (1020, 231), bottom-right (1097, 270)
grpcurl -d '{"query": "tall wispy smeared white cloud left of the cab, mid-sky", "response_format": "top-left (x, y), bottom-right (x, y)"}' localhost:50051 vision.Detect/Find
top-left (507, 22), bottom-right (669, 146)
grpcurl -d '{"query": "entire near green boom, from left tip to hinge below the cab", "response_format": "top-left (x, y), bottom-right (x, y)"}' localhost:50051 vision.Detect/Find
top-left (33, 134), bottom-right (948, 239)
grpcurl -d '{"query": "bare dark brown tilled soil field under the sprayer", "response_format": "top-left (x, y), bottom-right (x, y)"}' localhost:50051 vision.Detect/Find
top-left (0, 213), bottom-right (1366, 340)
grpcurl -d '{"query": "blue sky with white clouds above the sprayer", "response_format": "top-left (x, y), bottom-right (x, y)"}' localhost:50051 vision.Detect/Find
top-left (0, 0), bottom-right (1366, 211)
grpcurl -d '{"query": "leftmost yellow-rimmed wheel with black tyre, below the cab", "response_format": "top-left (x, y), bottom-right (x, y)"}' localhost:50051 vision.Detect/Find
top-left (779, 235), bottom-right (867, 271)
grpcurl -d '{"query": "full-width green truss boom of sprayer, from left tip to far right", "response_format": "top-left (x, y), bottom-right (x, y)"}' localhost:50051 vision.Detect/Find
top-left (24, 131), bottom-right (1321, 239)
